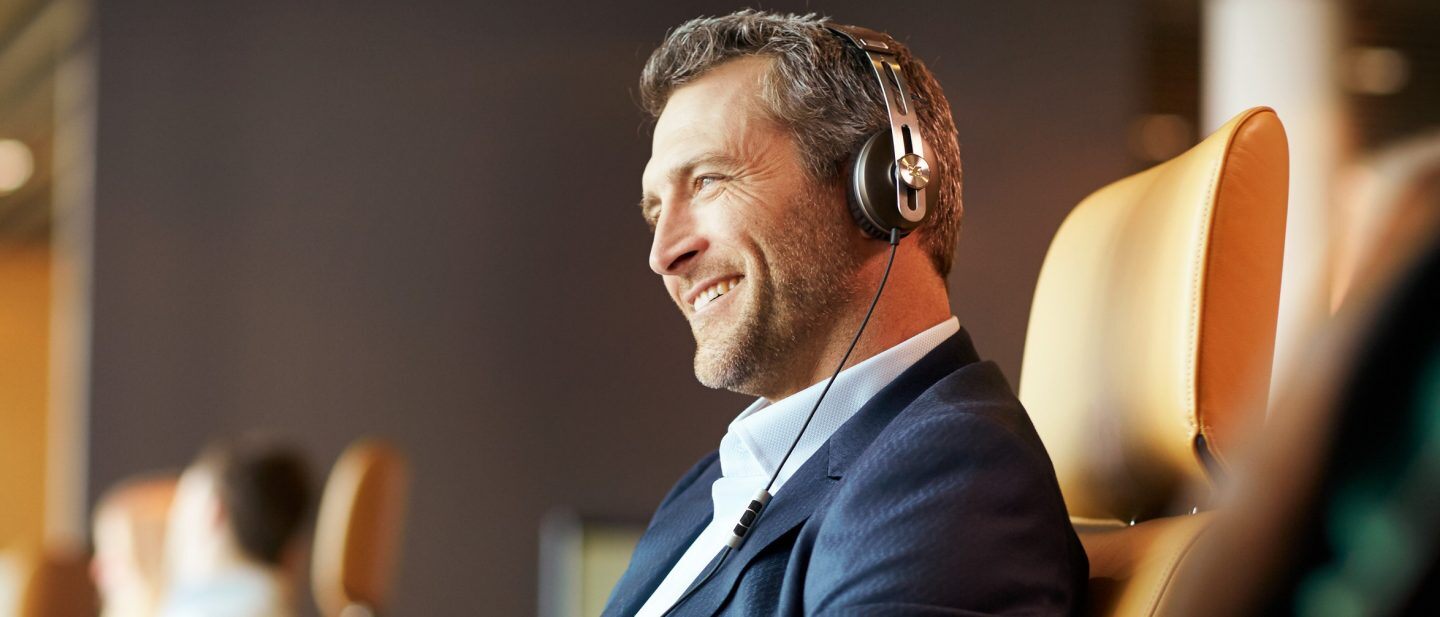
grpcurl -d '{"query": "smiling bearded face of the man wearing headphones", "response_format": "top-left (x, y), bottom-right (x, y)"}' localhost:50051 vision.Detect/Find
top-left (642, 58), bottom-right (860, 395)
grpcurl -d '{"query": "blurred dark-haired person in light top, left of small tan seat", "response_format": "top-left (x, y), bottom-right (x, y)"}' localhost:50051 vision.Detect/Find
top-left (160, 438), bottom-right (310, 617)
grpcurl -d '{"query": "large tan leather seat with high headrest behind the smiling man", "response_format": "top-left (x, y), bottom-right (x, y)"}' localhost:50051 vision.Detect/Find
top-left (1020, 108), bottom-right (1289, 616)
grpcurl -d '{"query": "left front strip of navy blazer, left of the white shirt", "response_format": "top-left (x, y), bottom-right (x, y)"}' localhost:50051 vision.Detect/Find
top-left (605, 458), bottom-right (720, 616)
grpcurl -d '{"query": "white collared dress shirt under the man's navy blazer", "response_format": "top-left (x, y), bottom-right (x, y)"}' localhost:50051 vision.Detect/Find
top-left (636, 316), bottom-right (960, 617)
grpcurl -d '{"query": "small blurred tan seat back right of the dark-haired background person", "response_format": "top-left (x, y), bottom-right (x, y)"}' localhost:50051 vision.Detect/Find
top-left (311, 440), bottom-right (409, 617)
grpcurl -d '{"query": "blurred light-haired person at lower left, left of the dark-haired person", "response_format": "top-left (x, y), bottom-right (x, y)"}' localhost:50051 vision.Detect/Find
top-left (91, 476), bottom-right (176, 617)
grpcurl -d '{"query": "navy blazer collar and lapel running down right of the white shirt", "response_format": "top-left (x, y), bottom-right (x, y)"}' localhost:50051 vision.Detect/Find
top-left (673, 329), bottom-right (979, 616)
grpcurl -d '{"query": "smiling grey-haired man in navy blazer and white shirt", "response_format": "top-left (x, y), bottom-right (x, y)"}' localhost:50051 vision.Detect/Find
top-left (605, 12), bottom-right (1087, 616)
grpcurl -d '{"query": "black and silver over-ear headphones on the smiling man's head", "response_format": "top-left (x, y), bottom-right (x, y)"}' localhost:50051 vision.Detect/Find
top-left (825, 23), bottom-right (935, 239)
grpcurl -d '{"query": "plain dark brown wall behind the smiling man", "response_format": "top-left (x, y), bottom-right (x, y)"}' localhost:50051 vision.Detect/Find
top-left (91, 0), bottom-right (1138, 616)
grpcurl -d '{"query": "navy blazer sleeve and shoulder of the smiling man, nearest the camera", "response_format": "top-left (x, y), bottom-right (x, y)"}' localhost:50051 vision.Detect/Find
top-left (801, 362), bottom-right (1087, 614)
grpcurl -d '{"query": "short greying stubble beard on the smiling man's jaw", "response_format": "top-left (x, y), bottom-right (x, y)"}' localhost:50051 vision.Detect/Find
top-left (691, 189), bottom-right (863, 396)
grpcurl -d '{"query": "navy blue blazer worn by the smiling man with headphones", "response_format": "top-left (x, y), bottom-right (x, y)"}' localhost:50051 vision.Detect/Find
top-left (605, 330), bottom-right (1089, 617)
